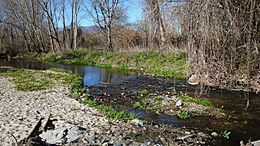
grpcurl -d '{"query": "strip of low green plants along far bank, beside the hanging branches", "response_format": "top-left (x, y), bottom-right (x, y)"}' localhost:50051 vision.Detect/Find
top-left (29, 50), bottom-right (187, 78)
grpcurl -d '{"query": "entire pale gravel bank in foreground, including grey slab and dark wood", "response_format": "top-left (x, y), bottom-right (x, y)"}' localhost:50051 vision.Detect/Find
top-left (0, 69), bottom-right (210, 146)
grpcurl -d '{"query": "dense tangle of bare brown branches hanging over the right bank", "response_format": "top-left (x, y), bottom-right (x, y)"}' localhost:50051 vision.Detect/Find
top-left (180, 0), bottom-right (260, 89)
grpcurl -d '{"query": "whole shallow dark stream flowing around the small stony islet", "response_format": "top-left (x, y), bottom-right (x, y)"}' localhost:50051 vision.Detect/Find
top-left (0, 60), bottom-right (260, 146)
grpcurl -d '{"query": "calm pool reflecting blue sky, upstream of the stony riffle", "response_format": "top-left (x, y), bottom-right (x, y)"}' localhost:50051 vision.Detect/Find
top-left (0, 60), bottom-right (132, 86)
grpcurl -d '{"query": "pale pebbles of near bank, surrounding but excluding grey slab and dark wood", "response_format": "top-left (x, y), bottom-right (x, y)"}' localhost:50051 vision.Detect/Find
top-left (0, 77), bottom-right (140, 146)
